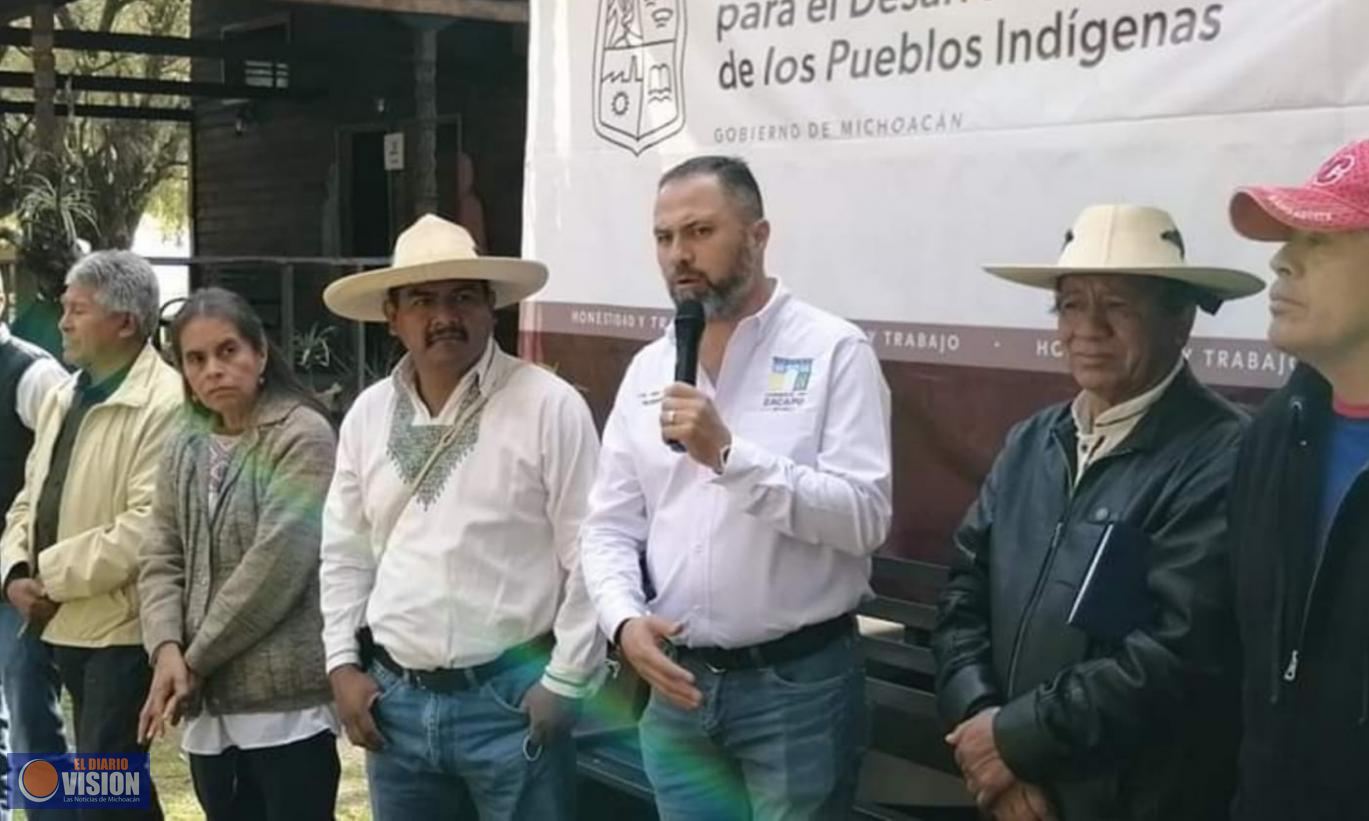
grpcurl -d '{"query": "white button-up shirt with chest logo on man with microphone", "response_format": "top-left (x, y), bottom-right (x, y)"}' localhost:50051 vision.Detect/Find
top-left (580, 283), bottom-right (891, 647)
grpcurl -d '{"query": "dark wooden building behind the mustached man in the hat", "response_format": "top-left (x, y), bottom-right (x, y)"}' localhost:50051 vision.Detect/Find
top-left (192, 0), bottom-right (528, 385)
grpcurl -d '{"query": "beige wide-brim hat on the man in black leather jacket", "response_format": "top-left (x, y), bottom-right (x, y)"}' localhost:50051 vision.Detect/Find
top-left (984, 205), bottom-right (1265, 301)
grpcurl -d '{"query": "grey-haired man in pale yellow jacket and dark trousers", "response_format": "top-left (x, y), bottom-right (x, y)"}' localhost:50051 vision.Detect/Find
top-left (0, 250), bottom-right (183, 818)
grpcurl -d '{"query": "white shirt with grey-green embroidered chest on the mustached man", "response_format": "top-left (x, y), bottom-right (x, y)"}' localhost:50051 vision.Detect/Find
top-left (320, 342), bottom-right (605, 698)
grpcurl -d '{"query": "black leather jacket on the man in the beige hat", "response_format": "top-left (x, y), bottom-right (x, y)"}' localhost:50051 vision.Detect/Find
top-left (932, 368), bottom-right (1246, 821)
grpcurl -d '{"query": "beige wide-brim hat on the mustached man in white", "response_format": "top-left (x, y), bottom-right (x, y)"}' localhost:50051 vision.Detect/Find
top-left (323, 213), bottom-right (546, 322)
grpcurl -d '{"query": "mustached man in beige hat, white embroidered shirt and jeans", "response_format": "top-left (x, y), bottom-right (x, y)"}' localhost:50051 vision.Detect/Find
top-left (320, 215), bottom-right (604, 821)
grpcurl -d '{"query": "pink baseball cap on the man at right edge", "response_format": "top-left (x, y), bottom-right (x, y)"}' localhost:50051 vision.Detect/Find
top-left (1231, 140), bottom-right (1369, 242)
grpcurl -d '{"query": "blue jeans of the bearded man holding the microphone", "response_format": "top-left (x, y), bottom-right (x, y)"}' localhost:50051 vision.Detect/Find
top-left (639, 635), bottom-right (869, 821)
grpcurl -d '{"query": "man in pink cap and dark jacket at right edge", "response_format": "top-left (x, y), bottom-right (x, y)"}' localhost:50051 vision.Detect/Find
top-left (1229, 141), bottom-right (1369, 821)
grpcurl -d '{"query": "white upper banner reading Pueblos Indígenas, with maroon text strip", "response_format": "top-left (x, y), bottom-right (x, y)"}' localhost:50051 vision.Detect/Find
top-left (523, 0), bottom-right (1369, 386)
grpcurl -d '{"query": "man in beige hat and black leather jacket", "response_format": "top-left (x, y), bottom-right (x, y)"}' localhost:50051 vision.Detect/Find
top-left (932, 205), bottom-right (1264, 821)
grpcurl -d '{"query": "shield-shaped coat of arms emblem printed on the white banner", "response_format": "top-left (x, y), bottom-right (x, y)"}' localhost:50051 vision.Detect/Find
top-left (594, 0), bottom-right (686, 155)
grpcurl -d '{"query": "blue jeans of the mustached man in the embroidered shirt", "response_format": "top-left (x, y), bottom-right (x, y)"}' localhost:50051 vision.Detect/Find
top-left (366, 661), bottom-right (575, 821)
